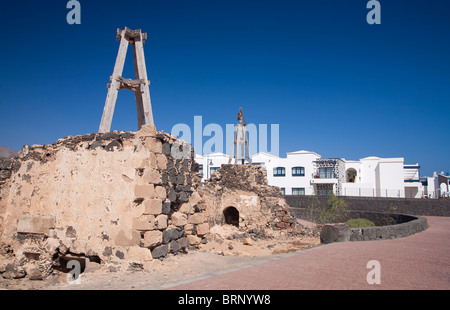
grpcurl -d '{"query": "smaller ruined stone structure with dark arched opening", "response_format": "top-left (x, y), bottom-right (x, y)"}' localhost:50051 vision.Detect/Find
top-left (199, 164), bottom-right (310, 234)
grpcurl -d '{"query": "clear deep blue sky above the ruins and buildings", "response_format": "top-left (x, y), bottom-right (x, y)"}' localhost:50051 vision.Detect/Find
top-left (0, 0), bottom-right (450, 176)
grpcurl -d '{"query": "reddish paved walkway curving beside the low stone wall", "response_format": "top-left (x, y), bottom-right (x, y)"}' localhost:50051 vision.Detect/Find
top-left (171, 217), bottom-right (450, 290)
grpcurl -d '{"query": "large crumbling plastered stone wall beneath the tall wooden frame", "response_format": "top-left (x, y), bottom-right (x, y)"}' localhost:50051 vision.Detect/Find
top-left (0, 125), bottom-right (209, 275)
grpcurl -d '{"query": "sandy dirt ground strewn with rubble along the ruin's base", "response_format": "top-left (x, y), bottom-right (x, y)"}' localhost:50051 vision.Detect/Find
top-left (0, 225), bottom-right (320, 290)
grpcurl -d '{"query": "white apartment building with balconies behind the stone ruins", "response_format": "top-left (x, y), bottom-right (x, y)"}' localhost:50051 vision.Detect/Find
top-left (195, 150), bottom-right (424, 198)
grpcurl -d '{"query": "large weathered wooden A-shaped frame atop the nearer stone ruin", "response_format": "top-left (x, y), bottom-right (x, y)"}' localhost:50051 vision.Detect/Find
top-left (98, 27), bottom-right (154, 133)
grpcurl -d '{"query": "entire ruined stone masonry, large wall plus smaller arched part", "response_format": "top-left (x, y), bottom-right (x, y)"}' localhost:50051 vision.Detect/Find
top-left (0, 125), bottom-right (316, 279)
